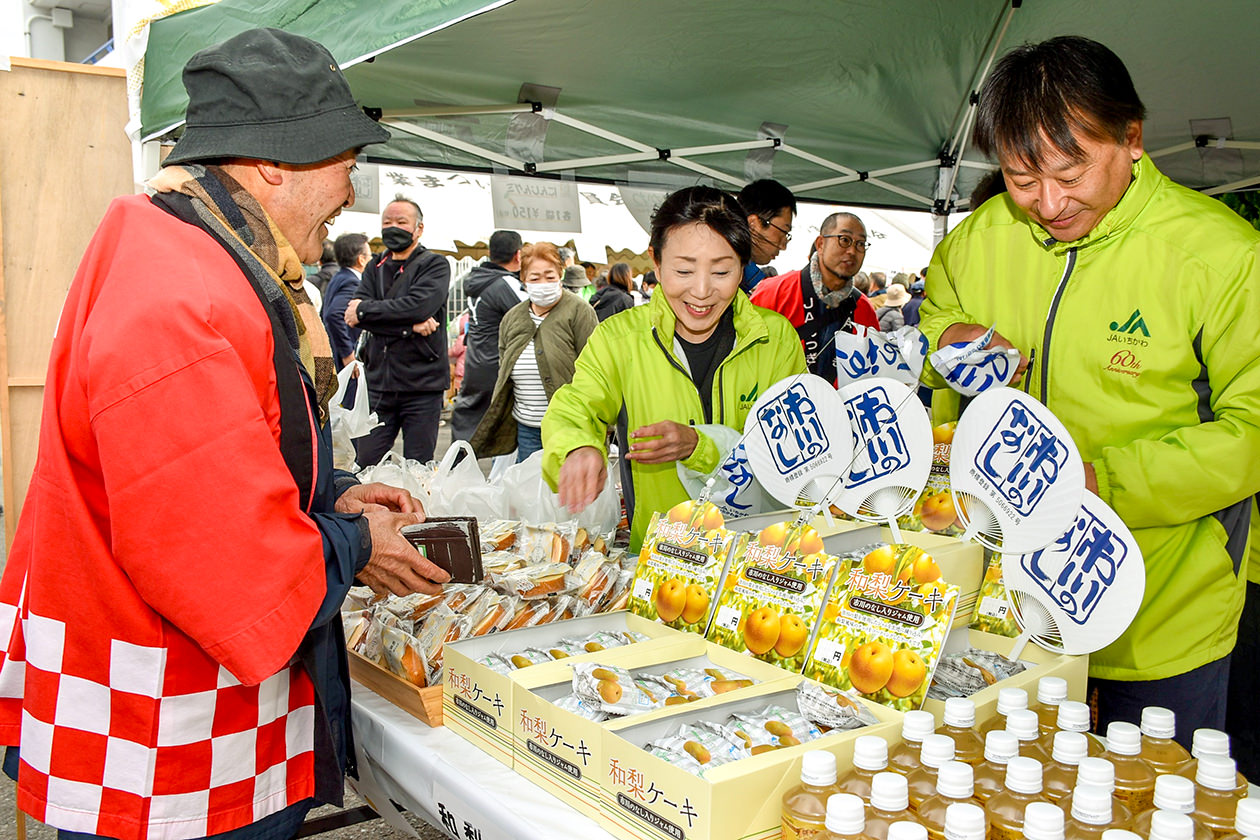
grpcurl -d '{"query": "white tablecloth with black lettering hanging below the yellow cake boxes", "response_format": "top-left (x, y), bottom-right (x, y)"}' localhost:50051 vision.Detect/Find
top-left (352, 683), bottom-right (612, 840)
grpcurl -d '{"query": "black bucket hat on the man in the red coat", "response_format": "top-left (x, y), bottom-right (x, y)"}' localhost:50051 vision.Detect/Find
top-left (163, 29), bottom-right (389, 166)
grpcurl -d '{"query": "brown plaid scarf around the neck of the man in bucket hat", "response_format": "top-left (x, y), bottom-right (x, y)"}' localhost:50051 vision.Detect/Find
top-left (149, 164), bottom-right (336, 426)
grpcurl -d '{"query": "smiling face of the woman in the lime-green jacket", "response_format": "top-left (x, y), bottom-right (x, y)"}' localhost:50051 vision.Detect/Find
top-left (653, 222), bottom-right (741, 344)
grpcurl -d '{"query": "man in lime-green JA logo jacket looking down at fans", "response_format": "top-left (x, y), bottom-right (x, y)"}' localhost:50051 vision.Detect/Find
top-left (921, 38), bottom-right (1260, 744)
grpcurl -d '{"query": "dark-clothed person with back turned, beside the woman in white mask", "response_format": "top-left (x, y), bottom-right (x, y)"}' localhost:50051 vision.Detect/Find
top-left (451, 230), bottom-right (529, 441)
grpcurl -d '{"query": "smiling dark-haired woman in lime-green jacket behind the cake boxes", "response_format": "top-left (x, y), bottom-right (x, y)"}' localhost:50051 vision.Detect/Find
top-left (543, 186), bottom-right (805, 552)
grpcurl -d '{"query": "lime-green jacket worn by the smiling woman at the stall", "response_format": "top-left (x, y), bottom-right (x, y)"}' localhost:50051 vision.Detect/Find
top-left (543, 292), bottom-right (805, 552)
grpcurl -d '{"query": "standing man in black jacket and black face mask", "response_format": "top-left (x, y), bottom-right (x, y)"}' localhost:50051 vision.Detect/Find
top-left (345, 195), bottom-right (451, 466)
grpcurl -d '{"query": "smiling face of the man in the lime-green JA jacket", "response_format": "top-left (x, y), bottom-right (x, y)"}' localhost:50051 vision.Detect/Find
top-left (999, 122), bottom-right (1142, 242)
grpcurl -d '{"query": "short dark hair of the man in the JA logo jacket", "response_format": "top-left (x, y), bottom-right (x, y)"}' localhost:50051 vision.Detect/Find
top-left (974, 35), bottom-right (1147, 169)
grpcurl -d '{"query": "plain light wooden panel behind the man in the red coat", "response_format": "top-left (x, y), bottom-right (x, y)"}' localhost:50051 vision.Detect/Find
top-left (0, 58), bottom-right (132, 551)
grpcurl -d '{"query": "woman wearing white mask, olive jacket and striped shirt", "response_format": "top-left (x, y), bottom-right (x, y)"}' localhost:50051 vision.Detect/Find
top-left (471, 242), bottom-right (599, 462)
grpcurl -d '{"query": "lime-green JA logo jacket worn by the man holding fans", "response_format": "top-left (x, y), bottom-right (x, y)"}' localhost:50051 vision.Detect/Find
top-left (921, 156), bottom-right (1260, 680)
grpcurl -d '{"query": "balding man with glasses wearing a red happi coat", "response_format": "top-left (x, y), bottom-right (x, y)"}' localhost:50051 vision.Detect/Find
top-left (752, 213), bottom-right (879, 384)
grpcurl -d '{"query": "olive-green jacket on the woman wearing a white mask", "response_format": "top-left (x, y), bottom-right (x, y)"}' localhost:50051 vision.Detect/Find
top-left (470, 290), bottom-right (599, 458)
